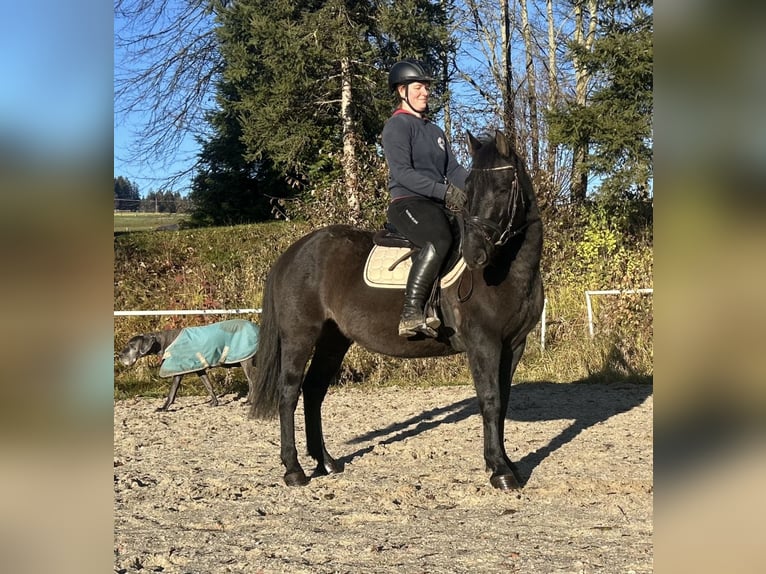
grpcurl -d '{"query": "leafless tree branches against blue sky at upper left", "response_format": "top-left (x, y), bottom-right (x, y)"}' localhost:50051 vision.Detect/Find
top-left (114, 0), bottom-right (229, 189)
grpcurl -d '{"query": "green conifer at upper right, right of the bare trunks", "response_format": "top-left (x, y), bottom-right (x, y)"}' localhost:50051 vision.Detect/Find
top-left (548, 0), bottom-right (653, 202)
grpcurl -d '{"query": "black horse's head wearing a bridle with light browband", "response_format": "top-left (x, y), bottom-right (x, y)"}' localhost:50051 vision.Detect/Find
top-left (463, 131), bottom-right (534, 269)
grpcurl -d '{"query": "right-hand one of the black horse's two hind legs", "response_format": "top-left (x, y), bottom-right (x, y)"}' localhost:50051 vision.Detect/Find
top-left (303, 323), bottom-right (351, 474)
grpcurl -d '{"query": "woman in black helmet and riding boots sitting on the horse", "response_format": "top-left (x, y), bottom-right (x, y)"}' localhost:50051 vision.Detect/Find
top-left (382, 60), bottom-right (468, 337)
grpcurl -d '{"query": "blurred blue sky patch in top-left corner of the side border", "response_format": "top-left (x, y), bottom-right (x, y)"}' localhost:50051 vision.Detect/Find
top-left (0, 0), bottom-right (112, 162)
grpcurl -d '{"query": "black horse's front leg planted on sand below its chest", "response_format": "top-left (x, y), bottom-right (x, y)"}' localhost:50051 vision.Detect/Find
top-left (469, 344), bottom-right (520, 490)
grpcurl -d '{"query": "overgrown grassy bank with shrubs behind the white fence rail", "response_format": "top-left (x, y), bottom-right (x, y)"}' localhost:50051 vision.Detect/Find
top-left (114, 217), bottom-right (653, 397)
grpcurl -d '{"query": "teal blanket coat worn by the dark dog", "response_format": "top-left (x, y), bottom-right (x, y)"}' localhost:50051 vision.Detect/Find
top-left (160, 319), bottom-right (259, 377)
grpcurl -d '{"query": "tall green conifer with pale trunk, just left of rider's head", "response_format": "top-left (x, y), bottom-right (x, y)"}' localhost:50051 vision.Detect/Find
top-left (207, 0), bottom-right (445, 225)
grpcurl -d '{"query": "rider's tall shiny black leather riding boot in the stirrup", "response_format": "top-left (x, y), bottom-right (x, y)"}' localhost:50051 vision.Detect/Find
top-left (399, 243), bottom-right (442, 337)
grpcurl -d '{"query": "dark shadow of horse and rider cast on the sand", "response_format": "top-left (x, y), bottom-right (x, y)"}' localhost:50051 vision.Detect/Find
top-left (340, 379), bottom-right (653, 486)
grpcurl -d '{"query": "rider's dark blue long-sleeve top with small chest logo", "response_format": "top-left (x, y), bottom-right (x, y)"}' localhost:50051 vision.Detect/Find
top-left (382, 110), bottom-right (468, 201)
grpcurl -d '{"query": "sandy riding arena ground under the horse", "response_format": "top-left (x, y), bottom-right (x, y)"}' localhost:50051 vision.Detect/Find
top-left (114, 383), bottom-right (653, 574)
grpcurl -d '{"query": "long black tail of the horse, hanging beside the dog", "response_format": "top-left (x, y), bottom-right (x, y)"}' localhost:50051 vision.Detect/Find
top-left (250, 274), bottom-right (282, 419)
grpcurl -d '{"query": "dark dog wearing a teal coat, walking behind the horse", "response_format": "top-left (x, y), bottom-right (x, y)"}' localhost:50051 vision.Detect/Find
top-left (117, 319), bottom-right (259, 412)
